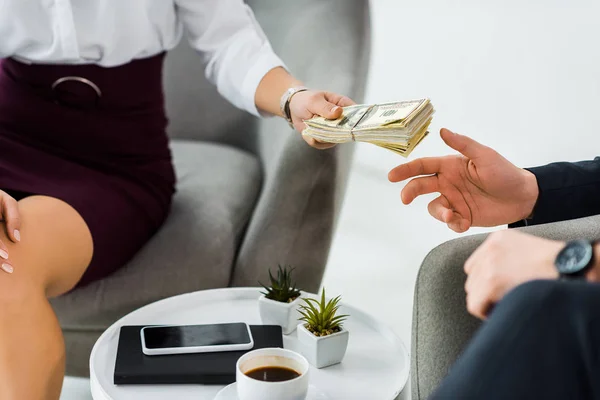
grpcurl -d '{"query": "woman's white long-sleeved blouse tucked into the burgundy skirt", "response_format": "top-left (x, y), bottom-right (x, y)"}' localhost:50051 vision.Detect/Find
top-left (0, 0), bottom-right (283, 115)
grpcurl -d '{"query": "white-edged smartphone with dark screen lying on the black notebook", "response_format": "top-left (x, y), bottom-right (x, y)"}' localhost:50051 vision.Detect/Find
top-left (140, 322), bottom-right (254, 356)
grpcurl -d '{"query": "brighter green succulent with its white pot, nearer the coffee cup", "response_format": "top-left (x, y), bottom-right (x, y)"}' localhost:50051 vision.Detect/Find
top-left (298, 289), bottom-right (350, 368)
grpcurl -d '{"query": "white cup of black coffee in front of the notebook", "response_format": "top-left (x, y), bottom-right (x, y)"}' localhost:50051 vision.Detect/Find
top-left (236, 348), bottom-right (309, 400)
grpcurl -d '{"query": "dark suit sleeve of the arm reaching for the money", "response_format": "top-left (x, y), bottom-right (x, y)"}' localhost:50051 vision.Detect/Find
top-left (509, 157), bottom-right (600, 228)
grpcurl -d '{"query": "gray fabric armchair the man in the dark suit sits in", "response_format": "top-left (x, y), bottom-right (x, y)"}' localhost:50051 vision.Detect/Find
top-left (411, 216), bottom-right (600, 399)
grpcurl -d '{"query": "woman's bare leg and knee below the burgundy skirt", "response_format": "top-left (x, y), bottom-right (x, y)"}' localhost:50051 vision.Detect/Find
top-left (0, 196), bottom-right (93, 400)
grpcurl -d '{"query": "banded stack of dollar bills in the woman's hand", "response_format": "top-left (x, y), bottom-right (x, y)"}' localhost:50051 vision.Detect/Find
top-left (302, 99), bottom-right (435, 157)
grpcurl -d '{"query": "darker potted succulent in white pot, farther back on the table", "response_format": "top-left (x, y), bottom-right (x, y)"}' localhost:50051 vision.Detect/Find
top-left (258, 266), bottom-right (301, 335)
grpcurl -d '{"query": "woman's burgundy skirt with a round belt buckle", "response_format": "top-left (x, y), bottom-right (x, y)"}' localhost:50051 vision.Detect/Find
top-left (0, 54), bottom-right (175, 286)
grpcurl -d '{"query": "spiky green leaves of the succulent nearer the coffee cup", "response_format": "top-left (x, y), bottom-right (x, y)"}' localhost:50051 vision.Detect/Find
top-left (299, 288), bottom-right (348, 336)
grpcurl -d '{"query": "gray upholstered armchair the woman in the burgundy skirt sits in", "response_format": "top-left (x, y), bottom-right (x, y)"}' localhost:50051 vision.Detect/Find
top-left (52, 0), bottom-right (370, 376)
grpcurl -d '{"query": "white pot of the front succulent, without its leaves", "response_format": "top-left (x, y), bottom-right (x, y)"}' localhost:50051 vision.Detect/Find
top-left (298, 322), bottom-right (350, 368)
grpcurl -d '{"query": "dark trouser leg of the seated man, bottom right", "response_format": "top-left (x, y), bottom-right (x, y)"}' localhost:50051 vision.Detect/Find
top-left (432, 281), bottom-right (600, 400)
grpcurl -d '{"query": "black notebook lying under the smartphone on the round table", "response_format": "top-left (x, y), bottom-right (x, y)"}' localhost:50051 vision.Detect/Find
top-left (114, 325), bottom-right (283, 385)
